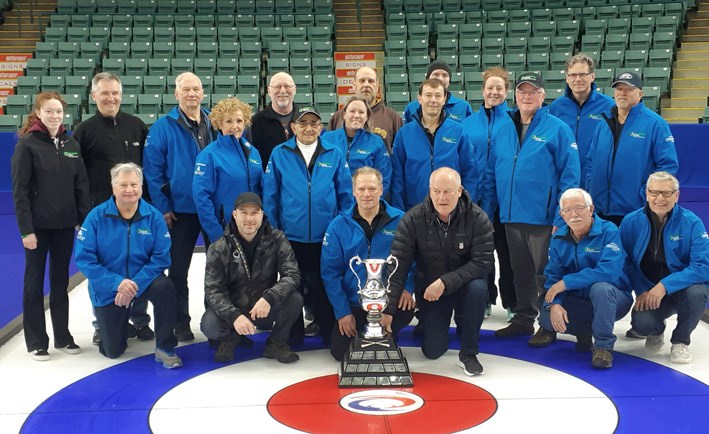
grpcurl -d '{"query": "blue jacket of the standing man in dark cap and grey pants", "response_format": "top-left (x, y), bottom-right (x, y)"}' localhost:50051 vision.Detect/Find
top-left (481, 107), bottom-right (579, 227)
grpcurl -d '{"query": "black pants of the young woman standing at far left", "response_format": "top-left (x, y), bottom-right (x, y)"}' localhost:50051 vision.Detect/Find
top-left (22, 228), bottom-right (74, 351)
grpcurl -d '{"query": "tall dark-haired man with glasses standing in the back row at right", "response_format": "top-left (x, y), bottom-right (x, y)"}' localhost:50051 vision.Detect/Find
top-left (549, 53), bottom-right (615, 183)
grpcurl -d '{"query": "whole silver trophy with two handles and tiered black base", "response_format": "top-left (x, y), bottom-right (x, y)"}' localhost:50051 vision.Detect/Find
top-left (339, 255), bottom-right (414, 387)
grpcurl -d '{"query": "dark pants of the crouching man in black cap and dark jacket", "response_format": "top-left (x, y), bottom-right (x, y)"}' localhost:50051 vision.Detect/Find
top-left (200, 292), bottom-right (303, 344)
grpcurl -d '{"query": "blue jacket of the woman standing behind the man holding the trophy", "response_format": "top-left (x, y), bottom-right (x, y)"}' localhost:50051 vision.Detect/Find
top-left (322, 127), bottom-right (391, 195)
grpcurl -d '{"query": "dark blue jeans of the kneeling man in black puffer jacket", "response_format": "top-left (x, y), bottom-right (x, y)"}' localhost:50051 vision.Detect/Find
top-left (417, 279), bottom-right (489, 359)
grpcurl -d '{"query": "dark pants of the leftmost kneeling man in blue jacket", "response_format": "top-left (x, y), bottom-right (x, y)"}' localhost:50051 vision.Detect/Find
top-left (94, 275), bottom-right (177, 359)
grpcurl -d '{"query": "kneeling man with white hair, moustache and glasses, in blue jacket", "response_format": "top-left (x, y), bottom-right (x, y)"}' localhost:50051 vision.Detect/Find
top-left (529, 188), bottom-right (633, 369)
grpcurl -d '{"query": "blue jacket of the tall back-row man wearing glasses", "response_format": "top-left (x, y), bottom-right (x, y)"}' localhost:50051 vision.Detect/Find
top-left (549, 83), bottom-right (615, 184)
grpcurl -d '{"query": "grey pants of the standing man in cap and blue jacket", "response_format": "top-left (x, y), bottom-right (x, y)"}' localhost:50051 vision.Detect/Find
top-left (505, 223), bottom-right (552, 324)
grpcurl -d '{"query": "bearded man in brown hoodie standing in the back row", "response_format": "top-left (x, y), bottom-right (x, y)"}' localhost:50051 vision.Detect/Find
top-left (327, 66), bottom-right (404, 153)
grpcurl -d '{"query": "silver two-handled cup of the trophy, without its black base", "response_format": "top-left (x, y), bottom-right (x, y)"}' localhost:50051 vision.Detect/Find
top-left (350, 255), bottom-right (399, 339)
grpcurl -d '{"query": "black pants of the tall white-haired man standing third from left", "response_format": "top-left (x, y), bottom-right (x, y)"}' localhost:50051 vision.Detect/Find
top-left (168, 212), bottom-right (206, 325)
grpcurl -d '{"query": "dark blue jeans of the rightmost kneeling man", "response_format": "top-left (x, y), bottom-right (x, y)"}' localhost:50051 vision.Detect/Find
top-left (631, 283), bottom-right (708, 345)
